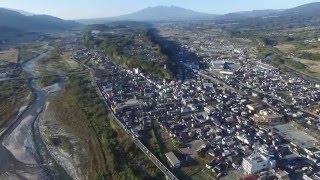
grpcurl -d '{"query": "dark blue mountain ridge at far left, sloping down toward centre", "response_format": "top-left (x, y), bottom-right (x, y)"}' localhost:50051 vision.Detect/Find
top-left (0, 8), bottom-right (80, 31)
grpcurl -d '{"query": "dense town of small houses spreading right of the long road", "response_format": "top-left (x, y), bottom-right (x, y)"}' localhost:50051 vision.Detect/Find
top-left (72, 22), bottom-right (320, 179)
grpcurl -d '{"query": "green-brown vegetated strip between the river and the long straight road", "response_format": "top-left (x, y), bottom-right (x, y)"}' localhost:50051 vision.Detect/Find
top-left (50, 75), bottom-right (163, 179)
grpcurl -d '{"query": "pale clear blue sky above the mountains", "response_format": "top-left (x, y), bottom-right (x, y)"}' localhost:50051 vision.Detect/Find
top-left (0, 0), bottom-right (315, 19)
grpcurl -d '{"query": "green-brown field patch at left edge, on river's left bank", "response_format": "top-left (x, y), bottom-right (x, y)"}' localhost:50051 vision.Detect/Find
top-left (0, 81), bottom-right (30, 129)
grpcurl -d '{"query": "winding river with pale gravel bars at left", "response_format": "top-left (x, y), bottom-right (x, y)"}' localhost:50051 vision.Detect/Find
top-left (0, 46), bottom-right (71, 180)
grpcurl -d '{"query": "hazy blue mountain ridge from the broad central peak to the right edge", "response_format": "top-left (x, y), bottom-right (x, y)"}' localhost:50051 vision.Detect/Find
top-left (77, 2), bottom-right (320, 24)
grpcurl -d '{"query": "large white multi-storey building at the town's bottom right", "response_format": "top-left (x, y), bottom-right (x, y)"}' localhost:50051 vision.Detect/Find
top-left (242, 152), bottom-right (276, 174)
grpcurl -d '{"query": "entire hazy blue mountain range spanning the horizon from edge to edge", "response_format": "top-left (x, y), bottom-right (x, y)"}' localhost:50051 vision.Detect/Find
top-left (0, 2), bottom-right (320, 32)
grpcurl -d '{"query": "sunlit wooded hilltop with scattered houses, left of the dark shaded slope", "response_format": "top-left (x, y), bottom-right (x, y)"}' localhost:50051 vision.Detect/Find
top-left (83, 27), bottom-right (171, 78)
